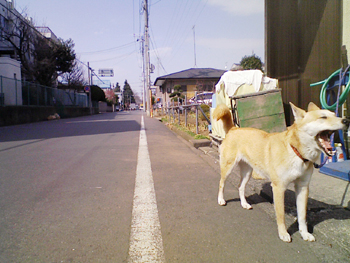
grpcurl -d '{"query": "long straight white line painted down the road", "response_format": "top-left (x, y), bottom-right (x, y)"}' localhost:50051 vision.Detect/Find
top-left (128, 116), bottom-right (165, 262)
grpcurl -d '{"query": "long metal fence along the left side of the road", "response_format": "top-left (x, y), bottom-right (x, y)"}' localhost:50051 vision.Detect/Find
top-left (0, 76), bottom-right (89, 107)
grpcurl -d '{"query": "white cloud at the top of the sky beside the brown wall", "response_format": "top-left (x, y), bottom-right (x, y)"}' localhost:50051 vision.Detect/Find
top-left (208, 0), bottom-right (264, 16)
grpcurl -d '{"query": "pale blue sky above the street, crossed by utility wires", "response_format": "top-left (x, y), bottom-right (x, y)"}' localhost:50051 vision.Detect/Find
top-left (13, 0), bottom-right (264, 95)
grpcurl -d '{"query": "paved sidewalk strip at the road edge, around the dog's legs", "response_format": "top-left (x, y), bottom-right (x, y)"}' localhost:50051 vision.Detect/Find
top-left (199, 147), bottom-right (350, 257)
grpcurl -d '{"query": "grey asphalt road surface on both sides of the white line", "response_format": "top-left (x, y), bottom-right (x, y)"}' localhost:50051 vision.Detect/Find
top-left (0, 112), bottom-right (346, 262)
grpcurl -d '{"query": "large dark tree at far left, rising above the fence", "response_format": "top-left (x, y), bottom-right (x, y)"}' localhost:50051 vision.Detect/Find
top-left (0, 11), bottom-right (75, 83)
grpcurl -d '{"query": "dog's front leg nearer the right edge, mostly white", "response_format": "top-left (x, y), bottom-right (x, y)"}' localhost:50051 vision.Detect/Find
top-left (295, 182), bottom-right (315, 241)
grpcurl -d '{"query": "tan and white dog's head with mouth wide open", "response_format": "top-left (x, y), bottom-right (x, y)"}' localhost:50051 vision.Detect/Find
top-left (290, 102), bottom-right (350, 156)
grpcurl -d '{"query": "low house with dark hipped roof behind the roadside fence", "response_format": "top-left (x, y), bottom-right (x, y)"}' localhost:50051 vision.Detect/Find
top-left (154, 68), bottom-right (226, 106)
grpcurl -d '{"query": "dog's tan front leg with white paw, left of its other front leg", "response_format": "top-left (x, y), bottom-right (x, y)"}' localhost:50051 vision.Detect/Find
top-left (271, 183), bottom-right (292, 242)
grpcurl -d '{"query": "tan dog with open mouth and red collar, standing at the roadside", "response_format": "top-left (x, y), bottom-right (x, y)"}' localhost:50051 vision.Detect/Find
top-left (213, 102), bottom-right (349, 242)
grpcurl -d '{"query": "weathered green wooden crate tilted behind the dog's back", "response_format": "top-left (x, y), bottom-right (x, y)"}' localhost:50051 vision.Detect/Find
top-left (231, 89), bottom-right (286, 132)
